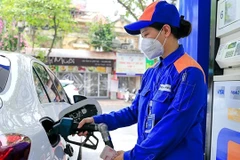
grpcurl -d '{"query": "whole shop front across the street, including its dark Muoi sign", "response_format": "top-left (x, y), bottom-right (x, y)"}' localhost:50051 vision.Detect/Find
top-left (40, 50), bottom-right (115, 98)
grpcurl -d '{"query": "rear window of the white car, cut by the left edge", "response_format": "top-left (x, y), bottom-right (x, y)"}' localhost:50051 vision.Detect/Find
top-left (0, 56), bottom-right (10, 93)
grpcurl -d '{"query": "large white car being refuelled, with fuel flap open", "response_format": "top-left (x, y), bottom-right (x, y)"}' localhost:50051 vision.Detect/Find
top-left (0, 51), bottom-right (101, 160)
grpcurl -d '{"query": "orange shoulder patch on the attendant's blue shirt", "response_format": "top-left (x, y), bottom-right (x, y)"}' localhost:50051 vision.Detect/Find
top-left (174, 53), bottom-right (206, 83)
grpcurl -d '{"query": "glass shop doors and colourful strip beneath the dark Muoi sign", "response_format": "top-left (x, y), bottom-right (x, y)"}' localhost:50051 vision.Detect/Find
top-left (55, 66), bottom-right (111, 98)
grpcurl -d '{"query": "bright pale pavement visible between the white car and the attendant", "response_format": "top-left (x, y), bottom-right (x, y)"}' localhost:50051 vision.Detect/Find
top-left (79, 100), bottom-right (137, 160)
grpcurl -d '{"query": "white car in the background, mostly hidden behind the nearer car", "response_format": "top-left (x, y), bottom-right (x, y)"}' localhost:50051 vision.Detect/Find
top-left (60, 79), bottom-right (79, 104)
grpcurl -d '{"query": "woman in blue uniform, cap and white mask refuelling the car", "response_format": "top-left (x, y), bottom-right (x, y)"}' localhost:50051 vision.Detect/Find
top-left (79, 1), bottom-right (207, 160)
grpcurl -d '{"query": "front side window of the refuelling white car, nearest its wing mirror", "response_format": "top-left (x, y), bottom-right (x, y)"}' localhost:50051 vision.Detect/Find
top-left (33, 63), bottom-right (61, 102)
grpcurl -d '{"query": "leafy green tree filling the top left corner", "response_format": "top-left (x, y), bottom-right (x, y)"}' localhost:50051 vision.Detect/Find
top-left (0, 0), bottom-right (73, 57)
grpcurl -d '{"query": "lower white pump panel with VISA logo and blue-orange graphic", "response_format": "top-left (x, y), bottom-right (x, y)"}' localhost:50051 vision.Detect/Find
top-left (211, 81), bottom-right (240, 160)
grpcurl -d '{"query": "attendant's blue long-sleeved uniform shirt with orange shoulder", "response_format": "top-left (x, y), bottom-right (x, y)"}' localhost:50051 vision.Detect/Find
top-left (94, 45), bottom-right (207, 160)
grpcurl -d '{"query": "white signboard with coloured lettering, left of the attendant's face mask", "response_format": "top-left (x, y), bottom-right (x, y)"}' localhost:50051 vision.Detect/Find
top-left (116, 53), bottom-right (146, 75)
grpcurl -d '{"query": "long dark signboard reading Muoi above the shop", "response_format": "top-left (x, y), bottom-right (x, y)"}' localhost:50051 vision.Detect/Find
top-left (49, 57), bottom-right (114, 67)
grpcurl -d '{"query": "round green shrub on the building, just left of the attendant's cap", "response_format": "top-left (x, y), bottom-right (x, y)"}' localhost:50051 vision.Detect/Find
top-left (88, 22), bottom-right (115, 52)
